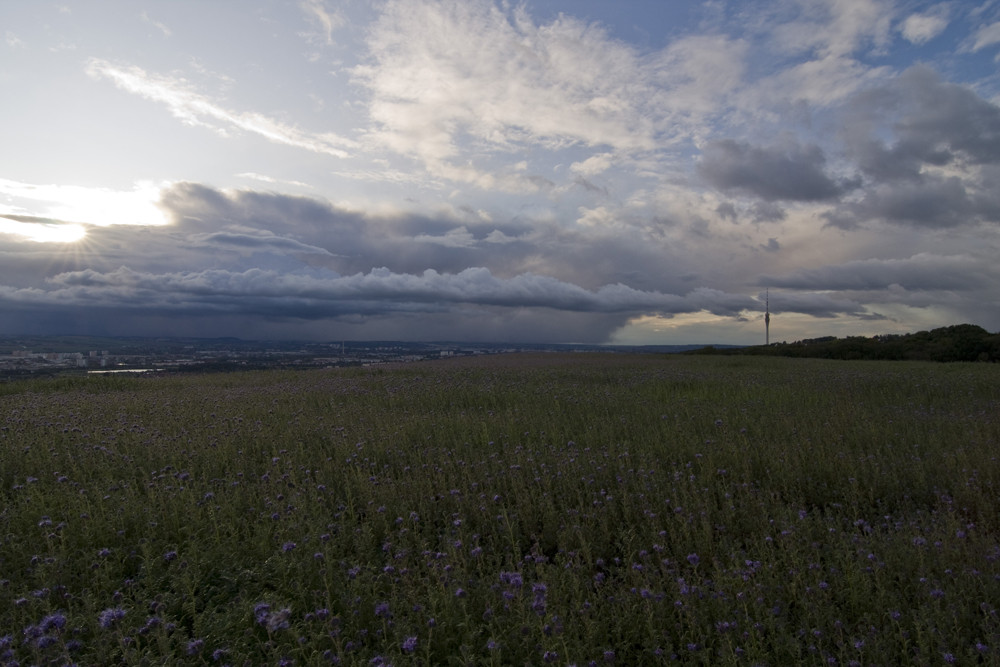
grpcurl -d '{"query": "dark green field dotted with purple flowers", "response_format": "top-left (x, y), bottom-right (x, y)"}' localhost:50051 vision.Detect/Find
top-left (0, 354), bottom-right (1000, 667)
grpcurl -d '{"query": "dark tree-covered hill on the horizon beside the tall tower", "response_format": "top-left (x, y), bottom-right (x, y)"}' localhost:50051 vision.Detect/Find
top-left (685, 324), bottom-right (1000, 362)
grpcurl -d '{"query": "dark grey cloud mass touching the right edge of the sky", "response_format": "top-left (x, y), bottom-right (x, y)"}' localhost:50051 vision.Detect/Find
top-left (824, 66), bottom-right (1000, 229)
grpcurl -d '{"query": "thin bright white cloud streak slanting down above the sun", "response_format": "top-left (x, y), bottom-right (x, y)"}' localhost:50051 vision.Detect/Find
top-left (87, 58), bottom-right (355, 158)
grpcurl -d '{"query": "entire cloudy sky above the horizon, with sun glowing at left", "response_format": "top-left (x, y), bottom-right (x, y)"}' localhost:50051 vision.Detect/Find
top-left (0, 0), bottom-right (1000, 344)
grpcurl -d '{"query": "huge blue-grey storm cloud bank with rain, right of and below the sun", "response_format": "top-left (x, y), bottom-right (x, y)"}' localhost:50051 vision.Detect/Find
top-left (0, 175), bottom-right (757, 342)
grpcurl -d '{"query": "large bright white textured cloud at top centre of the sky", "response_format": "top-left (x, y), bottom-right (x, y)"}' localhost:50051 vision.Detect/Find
top-left (354, 0), bottom-right (746, 183)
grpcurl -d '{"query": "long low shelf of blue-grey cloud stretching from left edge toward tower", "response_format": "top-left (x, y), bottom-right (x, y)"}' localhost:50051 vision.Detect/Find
top-left (29, 267), bottom-right (757, 319)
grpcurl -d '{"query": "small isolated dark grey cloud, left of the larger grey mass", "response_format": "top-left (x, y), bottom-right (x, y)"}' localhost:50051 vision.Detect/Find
top-left (698, 139), bottom-right (852, 201)
